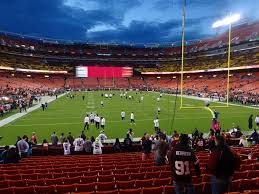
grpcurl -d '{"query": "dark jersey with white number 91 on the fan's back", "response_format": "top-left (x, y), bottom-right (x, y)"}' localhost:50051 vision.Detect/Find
top-left (171, 143), bottom-right (197, 183)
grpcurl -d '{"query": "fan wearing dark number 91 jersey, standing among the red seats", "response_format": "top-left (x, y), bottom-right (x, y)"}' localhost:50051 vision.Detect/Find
top-left (171, 134), bottom-right (200, 194)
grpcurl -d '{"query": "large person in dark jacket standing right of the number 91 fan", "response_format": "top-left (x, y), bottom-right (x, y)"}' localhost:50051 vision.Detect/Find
top-left (208, 135), bottom-right (241, 194)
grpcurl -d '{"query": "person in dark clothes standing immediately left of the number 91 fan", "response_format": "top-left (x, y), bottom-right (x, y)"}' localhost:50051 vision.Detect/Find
top-left (155, 135), bottom-right (169, 166)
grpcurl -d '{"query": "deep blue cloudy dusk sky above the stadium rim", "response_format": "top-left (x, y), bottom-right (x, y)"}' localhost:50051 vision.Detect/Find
top-left (0, 0), bottom-right (259, 44)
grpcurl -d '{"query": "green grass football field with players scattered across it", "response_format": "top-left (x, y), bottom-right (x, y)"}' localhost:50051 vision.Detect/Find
top-left (0, 91), bottom-right (258, 145)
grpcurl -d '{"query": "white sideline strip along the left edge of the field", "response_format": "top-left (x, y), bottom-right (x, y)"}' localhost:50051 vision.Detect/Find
top-left (0, 93), bottom-right (67, 127)
